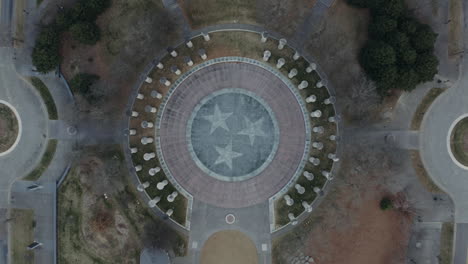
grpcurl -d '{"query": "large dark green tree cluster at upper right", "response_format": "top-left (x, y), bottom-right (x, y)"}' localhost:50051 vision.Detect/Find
top-left (347, 0), bottom-right (439, 95)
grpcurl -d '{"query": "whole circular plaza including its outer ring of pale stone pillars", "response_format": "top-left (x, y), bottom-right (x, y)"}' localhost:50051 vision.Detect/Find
top-left (126, 31), bottom-right (340, 231)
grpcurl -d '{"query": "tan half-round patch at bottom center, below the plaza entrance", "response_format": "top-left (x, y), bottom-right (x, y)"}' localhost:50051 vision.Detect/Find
top-left (200, 230), bottom-right (258, 264)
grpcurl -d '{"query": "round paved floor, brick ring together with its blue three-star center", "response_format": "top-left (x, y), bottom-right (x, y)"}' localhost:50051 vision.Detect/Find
top-left (157, 59), bottom-right (310, 207)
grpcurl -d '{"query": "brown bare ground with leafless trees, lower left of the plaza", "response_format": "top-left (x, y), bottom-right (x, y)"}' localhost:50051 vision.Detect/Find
top-left (57, 145), bottom-right (186, 264)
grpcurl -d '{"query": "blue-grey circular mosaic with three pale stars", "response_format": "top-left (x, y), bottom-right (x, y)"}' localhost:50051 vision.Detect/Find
top-left (187, 89), bottom-right (279, 181)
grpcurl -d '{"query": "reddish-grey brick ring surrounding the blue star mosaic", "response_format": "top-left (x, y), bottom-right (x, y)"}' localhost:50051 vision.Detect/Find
top-left (158, 62), bottom-right (307, 208)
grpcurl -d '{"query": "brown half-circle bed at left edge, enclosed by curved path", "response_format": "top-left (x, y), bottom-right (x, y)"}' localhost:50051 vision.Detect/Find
top-left (0, 104), bottom-right (19, 153)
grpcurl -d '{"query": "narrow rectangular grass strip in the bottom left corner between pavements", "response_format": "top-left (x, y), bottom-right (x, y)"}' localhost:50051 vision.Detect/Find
top-left (11, 209), bottom-right (35, 264)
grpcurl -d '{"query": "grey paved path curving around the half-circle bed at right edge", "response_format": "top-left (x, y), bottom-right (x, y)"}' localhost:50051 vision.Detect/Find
top-left (420, 2), bottom-right (468, 263)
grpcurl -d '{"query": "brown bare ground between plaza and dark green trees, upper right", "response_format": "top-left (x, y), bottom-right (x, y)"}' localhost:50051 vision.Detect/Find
top-left (306, 0), bottom-right (395, 124)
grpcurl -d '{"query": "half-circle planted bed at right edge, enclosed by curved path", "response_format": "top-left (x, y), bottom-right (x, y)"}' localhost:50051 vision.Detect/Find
top-left (450, 117), bottom-right (468, 166)
